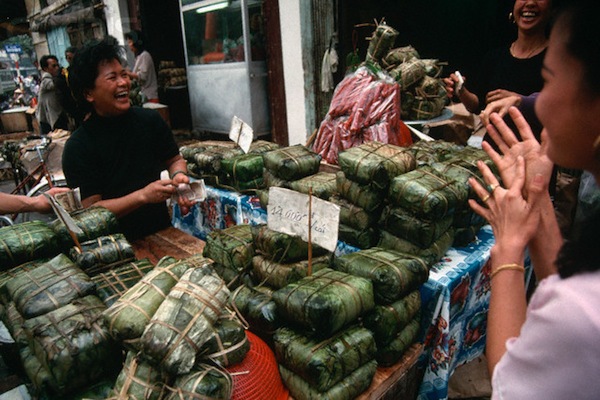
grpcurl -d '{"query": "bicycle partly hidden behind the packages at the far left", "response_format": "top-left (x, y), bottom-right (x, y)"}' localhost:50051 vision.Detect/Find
top-left (0, 136), bottom-right (67, 224)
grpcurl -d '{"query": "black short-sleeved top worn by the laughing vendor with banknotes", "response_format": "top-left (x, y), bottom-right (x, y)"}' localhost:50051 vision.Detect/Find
top-left (62, 107), bottom-right (179, 240)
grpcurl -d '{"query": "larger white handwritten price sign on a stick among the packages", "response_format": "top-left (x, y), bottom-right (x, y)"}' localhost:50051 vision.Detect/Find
top-left (267, 187), bottom-right (340, 251)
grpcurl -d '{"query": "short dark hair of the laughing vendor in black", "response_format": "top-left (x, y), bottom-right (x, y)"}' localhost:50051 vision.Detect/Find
top-left (69, 36), bottom-right (124, 112)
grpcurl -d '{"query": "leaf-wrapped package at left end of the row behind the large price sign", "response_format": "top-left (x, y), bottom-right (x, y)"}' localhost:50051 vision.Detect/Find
top-left (202, 224), bottom-right (254, 272)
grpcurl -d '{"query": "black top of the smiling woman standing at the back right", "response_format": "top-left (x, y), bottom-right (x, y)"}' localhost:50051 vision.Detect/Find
top-left (468, 48), bottom-right (546, 115)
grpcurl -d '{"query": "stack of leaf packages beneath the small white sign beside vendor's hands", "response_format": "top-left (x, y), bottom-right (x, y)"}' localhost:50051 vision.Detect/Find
top-left (179, 140), bottom-right (279, 193)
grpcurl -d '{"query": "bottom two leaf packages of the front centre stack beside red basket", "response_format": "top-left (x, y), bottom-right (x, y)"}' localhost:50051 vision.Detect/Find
top-left (274, 326), bottom-right (377, 399)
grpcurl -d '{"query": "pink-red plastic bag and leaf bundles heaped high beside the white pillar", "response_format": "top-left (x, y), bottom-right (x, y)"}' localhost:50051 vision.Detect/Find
top-left (312, 19), bottom-right (448, 165)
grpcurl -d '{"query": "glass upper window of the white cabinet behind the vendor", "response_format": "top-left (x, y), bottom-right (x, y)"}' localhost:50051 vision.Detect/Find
top-left (182, 0), bottom-right (266, 65)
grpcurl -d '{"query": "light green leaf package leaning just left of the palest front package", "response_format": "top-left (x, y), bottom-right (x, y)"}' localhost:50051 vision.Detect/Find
top-left (104, 257), bottom-right (209, 348)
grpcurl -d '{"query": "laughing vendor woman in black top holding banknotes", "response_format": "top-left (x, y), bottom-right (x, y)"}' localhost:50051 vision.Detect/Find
top-left (62, 37), bottom-right (191, 240)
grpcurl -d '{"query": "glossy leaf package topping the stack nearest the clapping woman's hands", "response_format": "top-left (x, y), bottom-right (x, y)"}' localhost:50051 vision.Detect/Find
top-left (388, 167), bottom-right (468, 220)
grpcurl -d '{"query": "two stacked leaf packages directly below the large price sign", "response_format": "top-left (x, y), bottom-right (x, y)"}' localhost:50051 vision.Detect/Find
top-left (251, 224), bottom-right (332, 289)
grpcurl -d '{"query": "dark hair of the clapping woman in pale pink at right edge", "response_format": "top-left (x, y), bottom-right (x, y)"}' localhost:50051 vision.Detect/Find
top-left (555, 0), bottom-right (600, 278)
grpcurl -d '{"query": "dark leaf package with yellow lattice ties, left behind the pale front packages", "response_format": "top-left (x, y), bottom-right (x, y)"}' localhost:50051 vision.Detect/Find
top-left (92, 258), bottom-right (154, 307)
